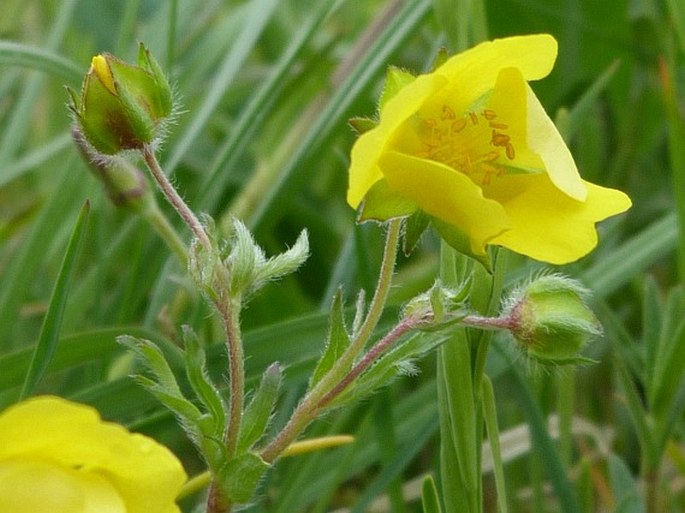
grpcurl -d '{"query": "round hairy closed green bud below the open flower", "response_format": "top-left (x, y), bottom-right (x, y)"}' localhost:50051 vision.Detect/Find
top-left (505, 275), bottom-right (602, 365)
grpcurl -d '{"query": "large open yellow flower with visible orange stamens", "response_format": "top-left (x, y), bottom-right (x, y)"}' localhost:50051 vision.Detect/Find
top-left (347, 34), bottom-right (631, 264)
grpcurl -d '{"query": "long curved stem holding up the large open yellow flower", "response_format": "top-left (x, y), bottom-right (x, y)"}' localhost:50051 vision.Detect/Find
top-left (260, 220), bottom-right (406, 463)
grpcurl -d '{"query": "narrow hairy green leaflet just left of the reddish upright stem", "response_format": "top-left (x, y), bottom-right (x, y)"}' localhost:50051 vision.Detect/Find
top-left (183, 326), bottom-right (226, 438)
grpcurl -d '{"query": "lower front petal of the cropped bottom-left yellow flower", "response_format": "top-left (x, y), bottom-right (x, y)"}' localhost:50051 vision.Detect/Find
top-left (0, 459), bottom-right (127, 513)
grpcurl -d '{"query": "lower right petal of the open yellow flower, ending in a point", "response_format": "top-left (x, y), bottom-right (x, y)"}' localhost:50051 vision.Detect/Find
top-left (490, 175), bottom-right (631, 264)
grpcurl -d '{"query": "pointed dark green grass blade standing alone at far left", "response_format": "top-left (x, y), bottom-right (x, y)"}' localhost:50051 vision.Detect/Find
top-left (19, 201), bottom-right (90, 399)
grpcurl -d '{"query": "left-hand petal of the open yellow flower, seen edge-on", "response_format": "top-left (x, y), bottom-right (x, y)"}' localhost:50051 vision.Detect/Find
top-left (347, 75), bottom-right (445, 208)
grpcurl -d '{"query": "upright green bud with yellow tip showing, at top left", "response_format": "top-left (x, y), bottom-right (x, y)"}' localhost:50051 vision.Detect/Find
top-left (67, 43), bottom-right (173, 155)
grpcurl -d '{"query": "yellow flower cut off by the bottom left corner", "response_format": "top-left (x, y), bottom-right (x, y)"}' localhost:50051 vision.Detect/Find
top-left (0, 396), bottom-right (186, 513)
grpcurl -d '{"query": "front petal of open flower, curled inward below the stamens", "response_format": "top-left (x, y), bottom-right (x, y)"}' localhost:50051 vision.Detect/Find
top-left (380, 151), bottom-right (509, 255)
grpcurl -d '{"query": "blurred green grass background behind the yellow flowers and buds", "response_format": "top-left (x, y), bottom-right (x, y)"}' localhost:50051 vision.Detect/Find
top-left (0, 0), bottom-right (685, 512)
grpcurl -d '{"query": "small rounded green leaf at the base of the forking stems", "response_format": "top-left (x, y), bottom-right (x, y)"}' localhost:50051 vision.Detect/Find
top-left (215, 452), bottom-right (269, 504)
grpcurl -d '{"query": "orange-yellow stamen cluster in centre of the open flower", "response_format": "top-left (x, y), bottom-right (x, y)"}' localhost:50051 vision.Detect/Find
top-left (418, 105), bottom-right (516, 185)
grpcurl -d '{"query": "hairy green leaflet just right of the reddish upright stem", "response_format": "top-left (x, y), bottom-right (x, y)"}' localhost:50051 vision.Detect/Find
top-left (236, 363), bottom-right (282, 453)
